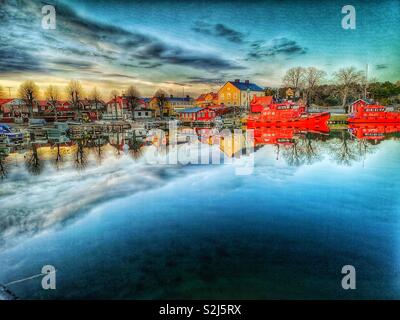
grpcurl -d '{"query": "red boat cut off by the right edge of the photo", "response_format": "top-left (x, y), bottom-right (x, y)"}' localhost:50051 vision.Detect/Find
top-left (347, 99), bottom-right (400, 123)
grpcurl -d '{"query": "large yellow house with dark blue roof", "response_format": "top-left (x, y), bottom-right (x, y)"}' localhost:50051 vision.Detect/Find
top-left (218, 79), bottom-right (264, 107)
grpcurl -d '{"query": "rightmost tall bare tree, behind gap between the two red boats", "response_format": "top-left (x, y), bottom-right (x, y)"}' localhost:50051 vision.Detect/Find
top-left (334, 67), bottom-right (364, 113)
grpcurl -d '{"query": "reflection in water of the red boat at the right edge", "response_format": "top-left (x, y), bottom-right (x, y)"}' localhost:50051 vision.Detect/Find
top-left (349, 123), bottom-right (400, 140)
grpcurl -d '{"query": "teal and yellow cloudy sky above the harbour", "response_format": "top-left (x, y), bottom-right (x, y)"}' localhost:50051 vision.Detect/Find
top-left (0, 0), bottom-right (400, 96)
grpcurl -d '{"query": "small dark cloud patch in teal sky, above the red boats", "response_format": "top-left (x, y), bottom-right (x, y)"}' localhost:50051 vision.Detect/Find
top-left (248, 38), bottom-right (307, 59)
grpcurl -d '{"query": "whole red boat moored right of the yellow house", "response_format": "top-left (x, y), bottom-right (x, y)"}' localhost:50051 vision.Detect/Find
top-left (247, 102), bottom-right (330, 129)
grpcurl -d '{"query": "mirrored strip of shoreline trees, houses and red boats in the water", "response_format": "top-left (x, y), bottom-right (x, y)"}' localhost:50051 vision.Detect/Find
top-left (0, 124), bottom-right (400, 179)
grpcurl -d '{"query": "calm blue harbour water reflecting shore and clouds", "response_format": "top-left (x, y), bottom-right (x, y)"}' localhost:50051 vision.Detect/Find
top-left (0, 130), bottom-right (400, 299)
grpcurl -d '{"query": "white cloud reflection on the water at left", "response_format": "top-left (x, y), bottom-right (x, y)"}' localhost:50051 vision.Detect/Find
top-left (0, 150), bottom-right (189, 250)
